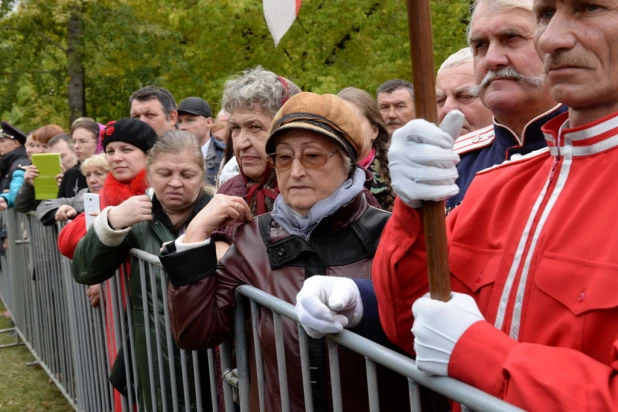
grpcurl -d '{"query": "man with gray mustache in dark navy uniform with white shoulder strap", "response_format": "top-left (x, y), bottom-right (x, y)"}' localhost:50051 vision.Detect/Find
top-left (446, 0), bottom-right (566, 212)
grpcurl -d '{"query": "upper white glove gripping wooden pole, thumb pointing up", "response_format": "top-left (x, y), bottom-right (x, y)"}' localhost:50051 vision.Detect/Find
top-left (388, 110), bottom-right (465, 208)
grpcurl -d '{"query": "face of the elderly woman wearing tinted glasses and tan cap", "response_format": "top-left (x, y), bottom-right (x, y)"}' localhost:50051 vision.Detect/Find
top-left (269, 129), bottom-right (349, 216)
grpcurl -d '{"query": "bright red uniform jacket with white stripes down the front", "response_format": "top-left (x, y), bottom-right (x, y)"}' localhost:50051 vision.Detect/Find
top-left (373, 113), bottom-right (618, 411)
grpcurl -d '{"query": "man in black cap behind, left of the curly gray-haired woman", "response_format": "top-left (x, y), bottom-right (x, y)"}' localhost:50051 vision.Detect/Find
top-left (178, 97), bottom-right (225, 185)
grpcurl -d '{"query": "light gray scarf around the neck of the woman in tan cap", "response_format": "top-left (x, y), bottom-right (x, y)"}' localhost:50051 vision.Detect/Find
top-left (270, 167), bottom-right (366, 239)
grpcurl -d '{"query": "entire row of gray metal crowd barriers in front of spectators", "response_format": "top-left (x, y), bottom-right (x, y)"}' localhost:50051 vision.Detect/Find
top-left (0, 210), bottom-right (520, 412)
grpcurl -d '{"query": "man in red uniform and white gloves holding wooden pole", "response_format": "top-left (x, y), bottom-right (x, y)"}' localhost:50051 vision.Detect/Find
top-left (297, 0), bottom-right (618, 412)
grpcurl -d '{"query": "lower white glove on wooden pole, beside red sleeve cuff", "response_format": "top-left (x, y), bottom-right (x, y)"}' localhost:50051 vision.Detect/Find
top-left (412, 292), bottom-right (485, 376)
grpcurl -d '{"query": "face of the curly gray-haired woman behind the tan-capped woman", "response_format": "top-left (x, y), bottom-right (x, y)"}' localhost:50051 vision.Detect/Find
top-left (229, 107), bottom-right (273, 182)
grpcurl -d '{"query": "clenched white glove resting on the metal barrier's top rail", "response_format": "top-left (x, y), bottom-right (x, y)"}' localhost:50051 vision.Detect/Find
top-left (296, 276), bottom-right (363, 339)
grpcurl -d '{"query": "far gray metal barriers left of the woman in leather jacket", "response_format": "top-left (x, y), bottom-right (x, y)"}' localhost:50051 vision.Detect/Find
top-left (0, 210), bottom-right (212, 412)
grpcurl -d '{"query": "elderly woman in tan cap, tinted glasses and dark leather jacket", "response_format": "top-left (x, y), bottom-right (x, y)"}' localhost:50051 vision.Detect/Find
top-left (161, 93), bottom-right (407, 411)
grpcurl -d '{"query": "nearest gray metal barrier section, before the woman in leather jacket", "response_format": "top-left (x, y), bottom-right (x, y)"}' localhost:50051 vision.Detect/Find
top-left (234, 286), bottom-right (521, 412)
